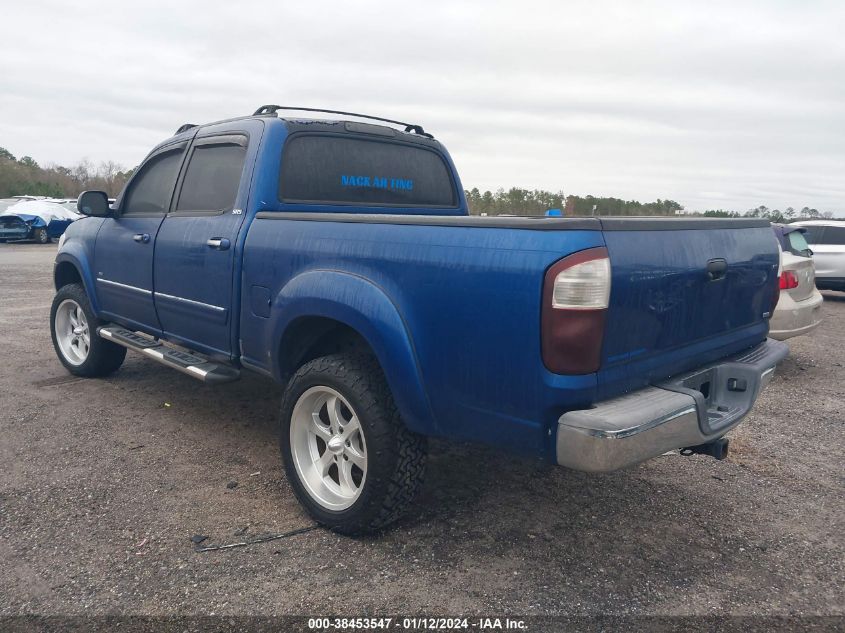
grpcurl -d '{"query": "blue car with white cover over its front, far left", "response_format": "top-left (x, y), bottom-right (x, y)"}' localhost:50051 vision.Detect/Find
top-left (0, 196), bottom-right (82, 244)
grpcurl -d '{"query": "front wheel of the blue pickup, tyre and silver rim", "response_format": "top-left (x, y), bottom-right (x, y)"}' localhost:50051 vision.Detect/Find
top-left (50, 284), bottom-right (126, 378)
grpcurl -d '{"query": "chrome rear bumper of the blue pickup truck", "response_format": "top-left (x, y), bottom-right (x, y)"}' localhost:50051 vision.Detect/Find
top-left (557, 339), bottom-right (789, 472)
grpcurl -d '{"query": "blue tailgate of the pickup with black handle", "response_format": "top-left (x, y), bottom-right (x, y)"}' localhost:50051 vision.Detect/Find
top-left (599, 218), bottom-right (778, 395)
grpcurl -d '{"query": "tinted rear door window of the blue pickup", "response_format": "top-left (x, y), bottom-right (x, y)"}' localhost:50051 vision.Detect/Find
top-left (176, 143), bottom-right (246, 214)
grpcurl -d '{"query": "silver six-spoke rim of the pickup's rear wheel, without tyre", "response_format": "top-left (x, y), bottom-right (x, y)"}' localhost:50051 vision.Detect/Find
top-left (290, 386), bottom-right (367, 511)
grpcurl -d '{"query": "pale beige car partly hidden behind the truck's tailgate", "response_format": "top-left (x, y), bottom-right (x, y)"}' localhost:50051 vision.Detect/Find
top-left (769, 224), bottom-right (824, 341)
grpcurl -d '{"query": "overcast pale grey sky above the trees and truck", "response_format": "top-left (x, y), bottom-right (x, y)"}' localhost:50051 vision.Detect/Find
top-left (0, 0), bottom-right (845, 216)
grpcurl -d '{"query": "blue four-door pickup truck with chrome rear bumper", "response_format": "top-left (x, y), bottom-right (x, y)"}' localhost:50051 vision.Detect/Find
top-left (51, 106), bottom-right (787, 534)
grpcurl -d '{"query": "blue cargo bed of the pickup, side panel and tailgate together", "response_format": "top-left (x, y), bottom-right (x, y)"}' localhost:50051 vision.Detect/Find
top-left (241, 211), bottom-right (777, 453)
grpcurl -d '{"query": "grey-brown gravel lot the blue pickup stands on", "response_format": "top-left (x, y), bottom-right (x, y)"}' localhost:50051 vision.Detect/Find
top-left (0, 245), bottom-right (845, 622)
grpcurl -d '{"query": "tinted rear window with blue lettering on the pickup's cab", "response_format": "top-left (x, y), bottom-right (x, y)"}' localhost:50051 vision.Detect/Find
top-left (279, 136), bottom-right (456, 207)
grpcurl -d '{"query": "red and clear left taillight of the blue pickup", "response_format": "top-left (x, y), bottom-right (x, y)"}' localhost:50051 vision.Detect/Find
top-left (541, 247), bottom-right (610, 374)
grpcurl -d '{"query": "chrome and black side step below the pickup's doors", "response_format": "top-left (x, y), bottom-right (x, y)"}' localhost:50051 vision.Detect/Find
top-left (97, 325), bottom-right (241, 385)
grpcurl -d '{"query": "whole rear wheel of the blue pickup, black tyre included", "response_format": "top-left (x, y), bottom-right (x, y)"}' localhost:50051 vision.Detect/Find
top-left (279, 354), bottom-right (426, 535)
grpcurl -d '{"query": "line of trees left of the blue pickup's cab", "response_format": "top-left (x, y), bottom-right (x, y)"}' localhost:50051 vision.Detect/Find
top-left (0, 147), bottom-right (134, 198)
